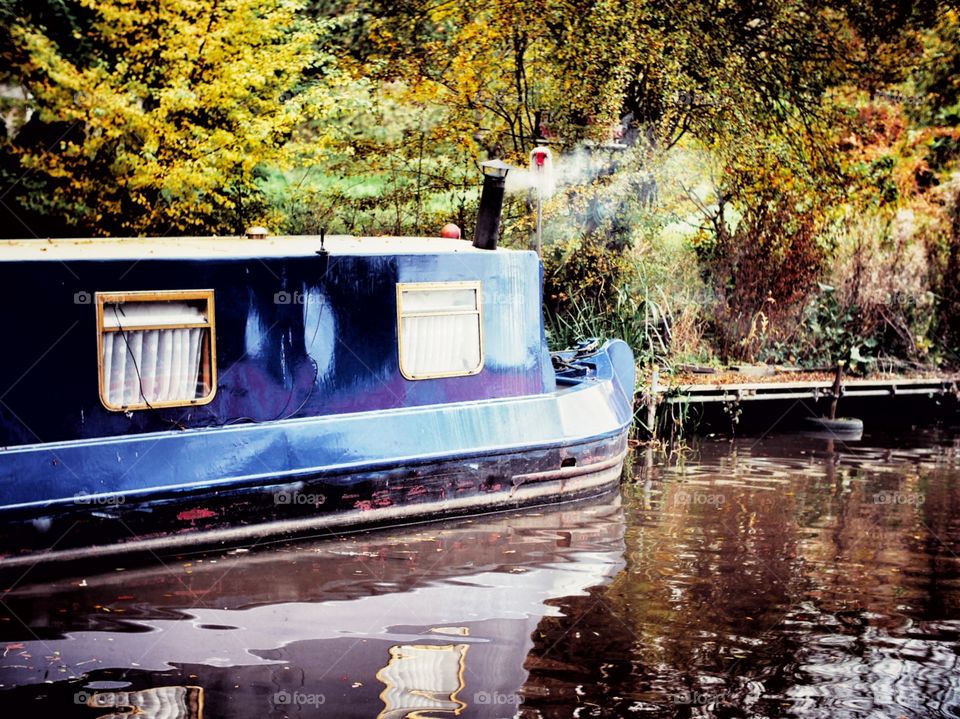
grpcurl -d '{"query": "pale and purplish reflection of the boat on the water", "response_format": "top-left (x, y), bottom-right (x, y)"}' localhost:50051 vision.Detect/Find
top-left (0, 496), bottom-right (624, 719)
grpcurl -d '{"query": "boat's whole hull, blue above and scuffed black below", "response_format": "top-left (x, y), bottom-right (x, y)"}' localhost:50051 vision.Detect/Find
top-left (0, 341), bottom-right (634, 568)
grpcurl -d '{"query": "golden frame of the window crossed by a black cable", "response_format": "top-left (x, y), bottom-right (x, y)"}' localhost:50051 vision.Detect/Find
top-left (94, 290), bottom-right (217, 412)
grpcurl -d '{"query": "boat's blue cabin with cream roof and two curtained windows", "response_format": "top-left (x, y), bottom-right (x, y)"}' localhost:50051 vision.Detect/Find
top-left (0, 237), bottom-right (556, 448)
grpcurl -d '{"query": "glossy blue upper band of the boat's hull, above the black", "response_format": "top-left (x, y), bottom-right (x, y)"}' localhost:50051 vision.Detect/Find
top-left (0, 341), bottom-right (633, 508)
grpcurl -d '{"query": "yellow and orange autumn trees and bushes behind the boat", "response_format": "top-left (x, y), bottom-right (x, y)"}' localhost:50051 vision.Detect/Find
top-left (0, 0), bottom-right (960, 365)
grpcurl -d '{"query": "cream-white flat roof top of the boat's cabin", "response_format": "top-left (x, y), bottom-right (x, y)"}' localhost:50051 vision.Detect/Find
top-left (0, 235), bottom-right (498, 262)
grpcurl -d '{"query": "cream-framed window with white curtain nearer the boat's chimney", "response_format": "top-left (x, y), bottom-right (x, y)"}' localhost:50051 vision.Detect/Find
top-left (397, 282), bottom-right (483, 379)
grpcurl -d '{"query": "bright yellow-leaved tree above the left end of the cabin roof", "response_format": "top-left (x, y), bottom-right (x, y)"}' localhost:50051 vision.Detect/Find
top-left (0, 0), bottom-right (352, 235)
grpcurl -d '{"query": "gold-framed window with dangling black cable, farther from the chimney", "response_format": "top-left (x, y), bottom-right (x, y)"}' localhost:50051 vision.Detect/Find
top-left (96, 290), bottom-right (217, 412)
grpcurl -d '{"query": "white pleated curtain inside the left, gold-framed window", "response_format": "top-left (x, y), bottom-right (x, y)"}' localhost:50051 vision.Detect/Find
top-left (103, 303), bottom-right (209, 406)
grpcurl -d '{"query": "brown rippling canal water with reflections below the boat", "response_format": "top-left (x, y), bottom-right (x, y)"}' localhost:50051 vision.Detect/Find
top-left (0, 430), bottom-right (960, 719)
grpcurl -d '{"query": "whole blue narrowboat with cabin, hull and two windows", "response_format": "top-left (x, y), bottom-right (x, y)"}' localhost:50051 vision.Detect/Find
top-left (0, 176), bottom-right (634, 568)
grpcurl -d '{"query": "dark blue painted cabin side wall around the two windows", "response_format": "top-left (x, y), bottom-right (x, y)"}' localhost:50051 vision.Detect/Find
top-left (0, 252), bottom-right (552, 444)
